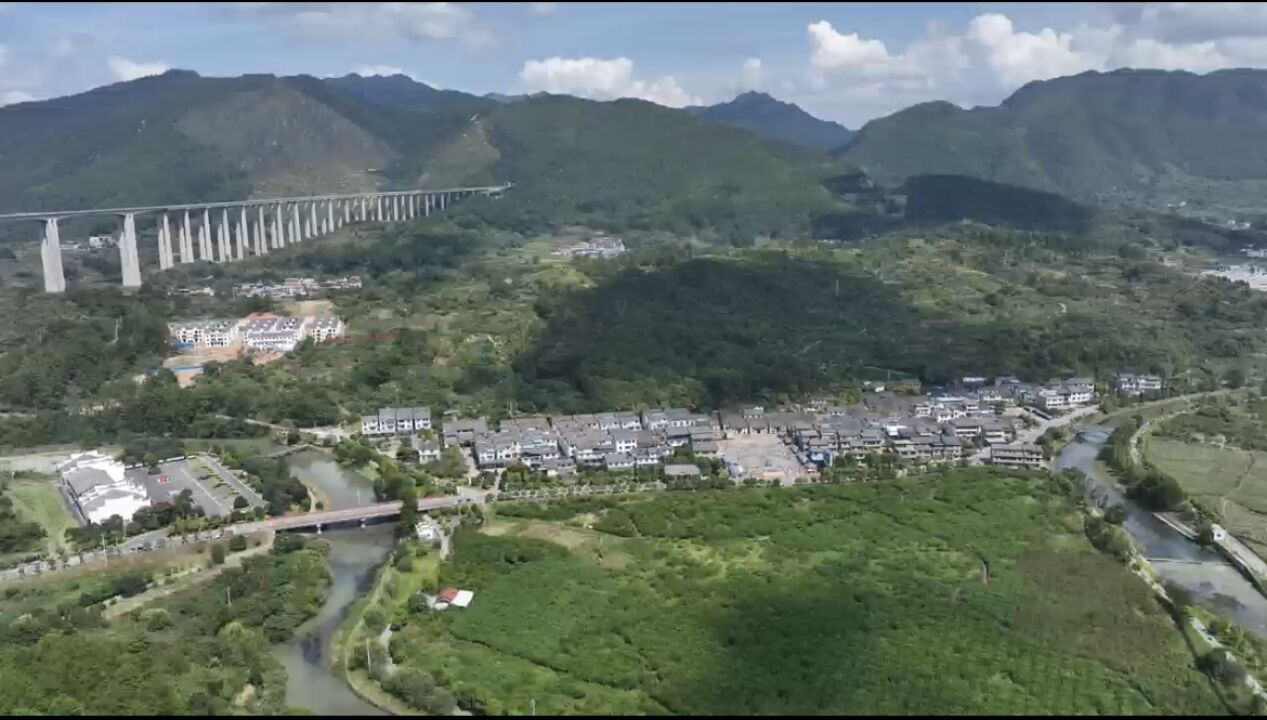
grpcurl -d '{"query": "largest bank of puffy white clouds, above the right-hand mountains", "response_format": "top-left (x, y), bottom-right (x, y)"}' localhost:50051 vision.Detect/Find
top-left (790, 3), bottom-right (1267, 125)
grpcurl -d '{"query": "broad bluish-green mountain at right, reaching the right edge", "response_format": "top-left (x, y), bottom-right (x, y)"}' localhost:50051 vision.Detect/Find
top-left (841, 70), bottom-right (1267, 210)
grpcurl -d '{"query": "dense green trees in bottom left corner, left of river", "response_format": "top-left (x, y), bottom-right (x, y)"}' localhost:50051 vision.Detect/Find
top-left (0, 543), bottom-right (328, 715)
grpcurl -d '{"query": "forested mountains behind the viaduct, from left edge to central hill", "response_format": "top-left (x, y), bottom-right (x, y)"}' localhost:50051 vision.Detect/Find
top-left (0, 71), bottom-right (839, 243)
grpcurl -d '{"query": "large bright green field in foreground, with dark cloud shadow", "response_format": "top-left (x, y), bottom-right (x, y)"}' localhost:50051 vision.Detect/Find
top-left (392, 468), bottom-right (1225, 715)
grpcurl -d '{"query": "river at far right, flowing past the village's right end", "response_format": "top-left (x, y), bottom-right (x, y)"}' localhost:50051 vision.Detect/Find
top-left (1053, 427), bottom-right (1267, 638)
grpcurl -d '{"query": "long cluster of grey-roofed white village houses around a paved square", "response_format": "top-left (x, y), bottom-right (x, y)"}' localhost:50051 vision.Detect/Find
top-left (360, 373), bottom-right (1163, 484)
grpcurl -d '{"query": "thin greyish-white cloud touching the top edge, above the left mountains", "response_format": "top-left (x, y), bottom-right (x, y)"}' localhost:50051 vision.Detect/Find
top-left (227, 3), bottom-right (497, 48)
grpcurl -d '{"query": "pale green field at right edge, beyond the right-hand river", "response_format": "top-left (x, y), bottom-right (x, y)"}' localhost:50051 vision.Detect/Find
top-left (1144, 437), bottom-right (1267, 553)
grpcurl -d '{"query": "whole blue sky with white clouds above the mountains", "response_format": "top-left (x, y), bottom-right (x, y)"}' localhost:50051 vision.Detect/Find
top-left (7, 3), bottom-right (1267, 128)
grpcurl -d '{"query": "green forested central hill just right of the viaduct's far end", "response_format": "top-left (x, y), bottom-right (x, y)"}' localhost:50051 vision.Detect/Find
top-left (451, 96), bottom-right (837, 245)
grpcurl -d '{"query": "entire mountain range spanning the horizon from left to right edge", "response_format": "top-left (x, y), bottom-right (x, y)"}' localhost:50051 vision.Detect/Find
top-left (12, 70), bottom-right (1267, 230)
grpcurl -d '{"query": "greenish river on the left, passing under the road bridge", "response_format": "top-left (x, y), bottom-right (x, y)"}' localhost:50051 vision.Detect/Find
top-left (274, 450), bottom-right (395, 715)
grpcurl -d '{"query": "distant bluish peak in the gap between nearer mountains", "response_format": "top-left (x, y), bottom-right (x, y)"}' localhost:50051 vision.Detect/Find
top-left (685, 93), bottom-right (854, 150)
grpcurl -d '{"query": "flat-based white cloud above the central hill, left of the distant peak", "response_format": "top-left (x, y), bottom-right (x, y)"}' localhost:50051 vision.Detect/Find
top-left (519, 57), bottom-right (703, 108)
